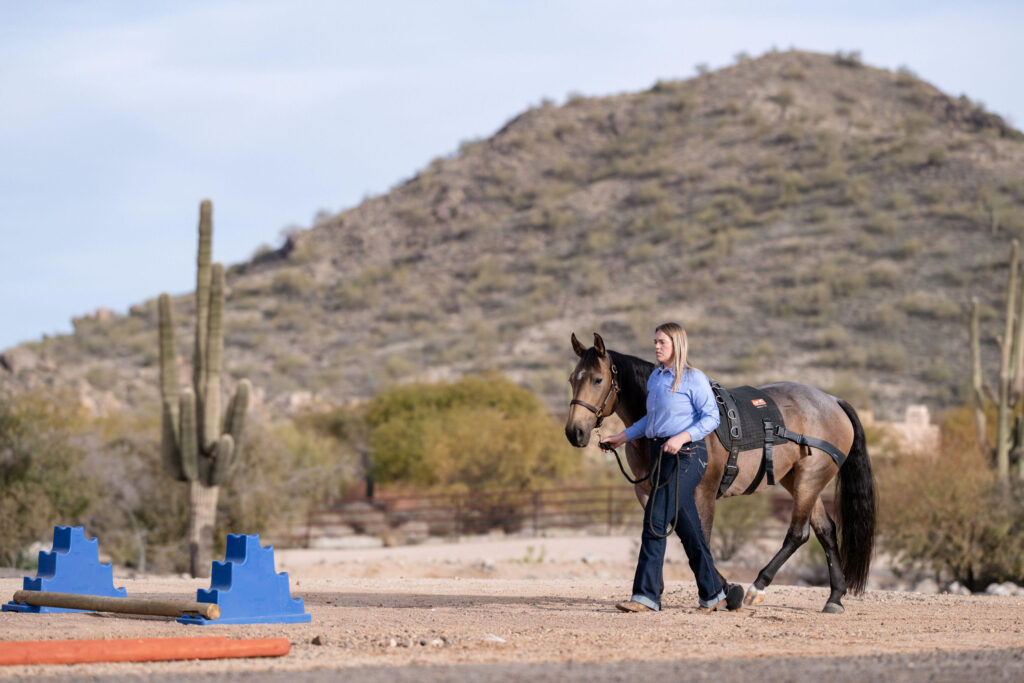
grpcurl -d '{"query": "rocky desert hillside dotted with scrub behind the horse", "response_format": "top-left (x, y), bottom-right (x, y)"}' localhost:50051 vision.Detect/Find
top-left (0, 51), bottom-right (1024, 415)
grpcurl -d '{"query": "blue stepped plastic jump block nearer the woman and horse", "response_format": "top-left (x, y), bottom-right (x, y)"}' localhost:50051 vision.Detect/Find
top-left (177, 533), bottom-right (312, 626)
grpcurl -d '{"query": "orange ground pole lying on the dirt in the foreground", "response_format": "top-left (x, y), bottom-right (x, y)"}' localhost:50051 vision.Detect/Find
top-left (0, 636), bottom-right (291, 667)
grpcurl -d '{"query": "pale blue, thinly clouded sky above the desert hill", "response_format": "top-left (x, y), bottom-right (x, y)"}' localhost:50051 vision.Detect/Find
top-left (0, 0), bottom-right (1024, 350)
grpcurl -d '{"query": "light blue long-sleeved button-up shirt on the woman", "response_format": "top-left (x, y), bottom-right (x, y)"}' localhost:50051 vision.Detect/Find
top-left (626, 366), bottom-right (719, 441)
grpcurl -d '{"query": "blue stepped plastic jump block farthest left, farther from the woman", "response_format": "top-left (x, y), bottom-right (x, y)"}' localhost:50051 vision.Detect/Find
top-left (2, 526), bottom-right (128, 614)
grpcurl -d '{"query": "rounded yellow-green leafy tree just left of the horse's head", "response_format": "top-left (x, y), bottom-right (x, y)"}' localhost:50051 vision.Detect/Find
top-left (367, 373), bottom-right (581, 490)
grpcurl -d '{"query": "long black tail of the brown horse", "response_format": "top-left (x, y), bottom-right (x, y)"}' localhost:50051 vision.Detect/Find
top-left (836, 398), bottom-right (876, 594)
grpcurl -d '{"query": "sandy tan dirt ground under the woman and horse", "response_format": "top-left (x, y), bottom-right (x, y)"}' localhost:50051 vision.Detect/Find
top-left (0, 537), bottom-right (1024, 682)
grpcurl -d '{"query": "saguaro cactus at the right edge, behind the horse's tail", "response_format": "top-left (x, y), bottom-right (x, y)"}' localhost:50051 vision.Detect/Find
top-left (970, 240), bottom-right (1024, 481)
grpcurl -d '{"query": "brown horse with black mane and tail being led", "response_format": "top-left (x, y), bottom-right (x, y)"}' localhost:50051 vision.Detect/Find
top-left (565, 333), bottom-right (876, 614)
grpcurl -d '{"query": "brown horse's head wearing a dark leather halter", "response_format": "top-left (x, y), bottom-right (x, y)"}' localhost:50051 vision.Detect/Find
top-left (565, 333), bottom-right (618, 447)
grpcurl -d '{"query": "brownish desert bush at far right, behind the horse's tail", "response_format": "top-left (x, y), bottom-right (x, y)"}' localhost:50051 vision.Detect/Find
top-left (879, 408), bottom-right (1024, 591)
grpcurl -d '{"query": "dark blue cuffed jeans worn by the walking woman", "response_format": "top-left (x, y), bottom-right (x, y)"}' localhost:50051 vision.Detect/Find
top-left (632, 438), bottom-right (725, 609)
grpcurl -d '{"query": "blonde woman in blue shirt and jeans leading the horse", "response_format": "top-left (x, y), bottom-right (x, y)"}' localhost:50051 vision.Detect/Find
top-left (603, 323), bottom-right (742, 612)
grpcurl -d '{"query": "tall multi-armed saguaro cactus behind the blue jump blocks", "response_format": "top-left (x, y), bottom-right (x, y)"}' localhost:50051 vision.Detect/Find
top-left (160, 200), bottom-right (252, 577)
